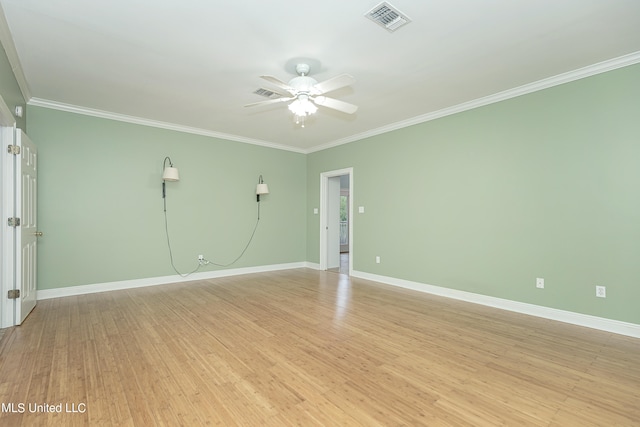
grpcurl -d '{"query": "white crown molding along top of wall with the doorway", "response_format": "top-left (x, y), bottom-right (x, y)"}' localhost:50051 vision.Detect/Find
top-left (306, 51), bottom-right (640, 154)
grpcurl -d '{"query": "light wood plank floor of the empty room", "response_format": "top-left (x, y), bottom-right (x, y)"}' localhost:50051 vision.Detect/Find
top-left (0, 269), bottom-right (640, 426)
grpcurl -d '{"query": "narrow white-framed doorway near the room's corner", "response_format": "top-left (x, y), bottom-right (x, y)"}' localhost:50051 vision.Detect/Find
top-left (320, 168), bottom-right (353, 275)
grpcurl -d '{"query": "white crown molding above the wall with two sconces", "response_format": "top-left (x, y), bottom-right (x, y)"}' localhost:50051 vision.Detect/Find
top-left (27, 98), bottom-right (304, 154)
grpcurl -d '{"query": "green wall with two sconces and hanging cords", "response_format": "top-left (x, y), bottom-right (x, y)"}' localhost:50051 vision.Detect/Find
top-left (29, 106), bottom-right (306, 290)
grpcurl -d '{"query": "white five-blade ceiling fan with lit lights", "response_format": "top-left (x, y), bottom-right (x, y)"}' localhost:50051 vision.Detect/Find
top-left (245, 63), bottom-right (358, 127)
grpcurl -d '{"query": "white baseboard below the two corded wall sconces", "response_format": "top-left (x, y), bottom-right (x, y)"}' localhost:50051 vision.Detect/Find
top-left (36, 262), bottom-right (307, 300)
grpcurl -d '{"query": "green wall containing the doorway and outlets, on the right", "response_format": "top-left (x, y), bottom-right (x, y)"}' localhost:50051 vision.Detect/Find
top-left (306, 65), bottom-right (640, 324)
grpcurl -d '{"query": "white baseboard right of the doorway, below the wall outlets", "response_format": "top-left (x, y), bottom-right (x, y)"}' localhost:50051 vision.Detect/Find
top-left (352, 270), bottom-right (640, 338)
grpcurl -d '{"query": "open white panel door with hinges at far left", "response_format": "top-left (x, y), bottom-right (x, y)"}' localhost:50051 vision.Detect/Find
top-left (15, 131), bottom-right (38, 325)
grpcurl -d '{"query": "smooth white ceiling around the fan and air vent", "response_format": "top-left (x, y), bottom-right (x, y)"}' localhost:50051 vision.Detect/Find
top-left (0, 0), bottom-right (640, 152)
